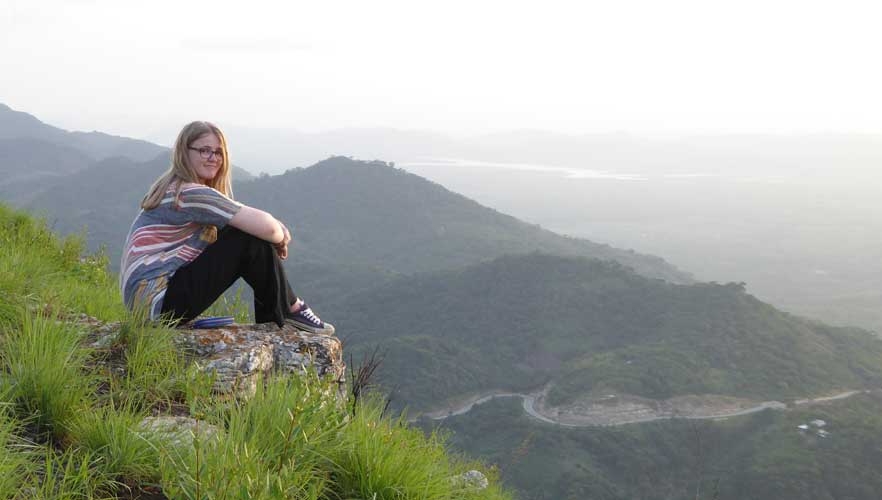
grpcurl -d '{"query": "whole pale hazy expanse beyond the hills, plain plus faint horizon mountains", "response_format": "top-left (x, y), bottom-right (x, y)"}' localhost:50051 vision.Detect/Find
top-left (144, 122), bottom-right (882, 332)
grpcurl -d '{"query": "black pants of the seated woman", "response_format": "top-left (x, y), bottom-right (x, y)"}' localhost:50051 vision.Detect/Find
top-left (162, 226), bottom-right (297, 326)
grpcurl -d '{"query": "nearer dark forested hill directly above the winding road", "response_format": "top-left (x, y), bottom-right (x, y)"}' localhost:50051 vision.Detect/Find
top-left (326, 254), bottom-right (882, 409)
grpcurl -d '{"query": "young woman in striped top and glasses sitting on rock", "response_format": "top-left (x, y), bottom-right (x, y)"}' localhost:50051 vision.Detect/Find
top-left (120, 122), bottom-right (334, 334)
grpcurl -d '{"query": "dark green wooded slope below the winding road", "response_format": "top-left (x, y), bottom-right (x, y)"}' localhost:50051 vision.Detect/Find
top-left (427, 393), bottom-right (882, 500)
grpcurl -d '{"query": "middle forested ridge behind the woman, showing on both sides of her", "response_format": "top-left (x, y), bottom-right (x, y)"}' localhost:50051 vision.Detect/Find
top-left (0, 148), bottom-right (690, 292)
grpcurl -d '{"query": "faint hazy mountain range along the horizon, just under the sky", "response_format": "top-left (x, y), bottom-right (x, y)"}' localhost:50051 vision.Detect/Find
top-left (151, 125), bottom-right (882, 182)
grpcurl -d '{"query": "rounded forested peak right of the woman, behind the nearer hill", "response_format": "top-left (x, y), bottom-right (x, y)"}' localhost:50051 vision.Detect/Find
top-left (237, 156), bottom-right (691, 282)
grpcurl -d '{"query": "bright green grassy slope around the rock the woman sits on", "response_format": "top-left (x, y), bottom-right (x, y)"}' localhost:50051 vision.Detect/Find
top-left (0, 205), bottom-right (508, 500)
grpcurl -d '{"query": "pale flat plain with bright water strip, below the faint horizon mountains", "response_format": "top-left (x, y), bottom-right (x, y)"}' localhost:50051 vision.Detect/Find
top-left (402, 142), bottom-right (882, 331)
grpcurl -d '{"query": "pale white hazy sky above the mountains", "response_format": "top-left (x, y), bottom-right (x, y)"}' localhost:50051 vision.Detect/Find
top-left (0, 0), bottom-right (882, 136)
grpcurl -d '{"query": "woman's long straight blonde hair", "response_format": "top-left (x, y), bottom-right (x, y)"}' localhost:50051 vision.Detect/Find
top-left (141, 122), bottom-right (233, 210)
